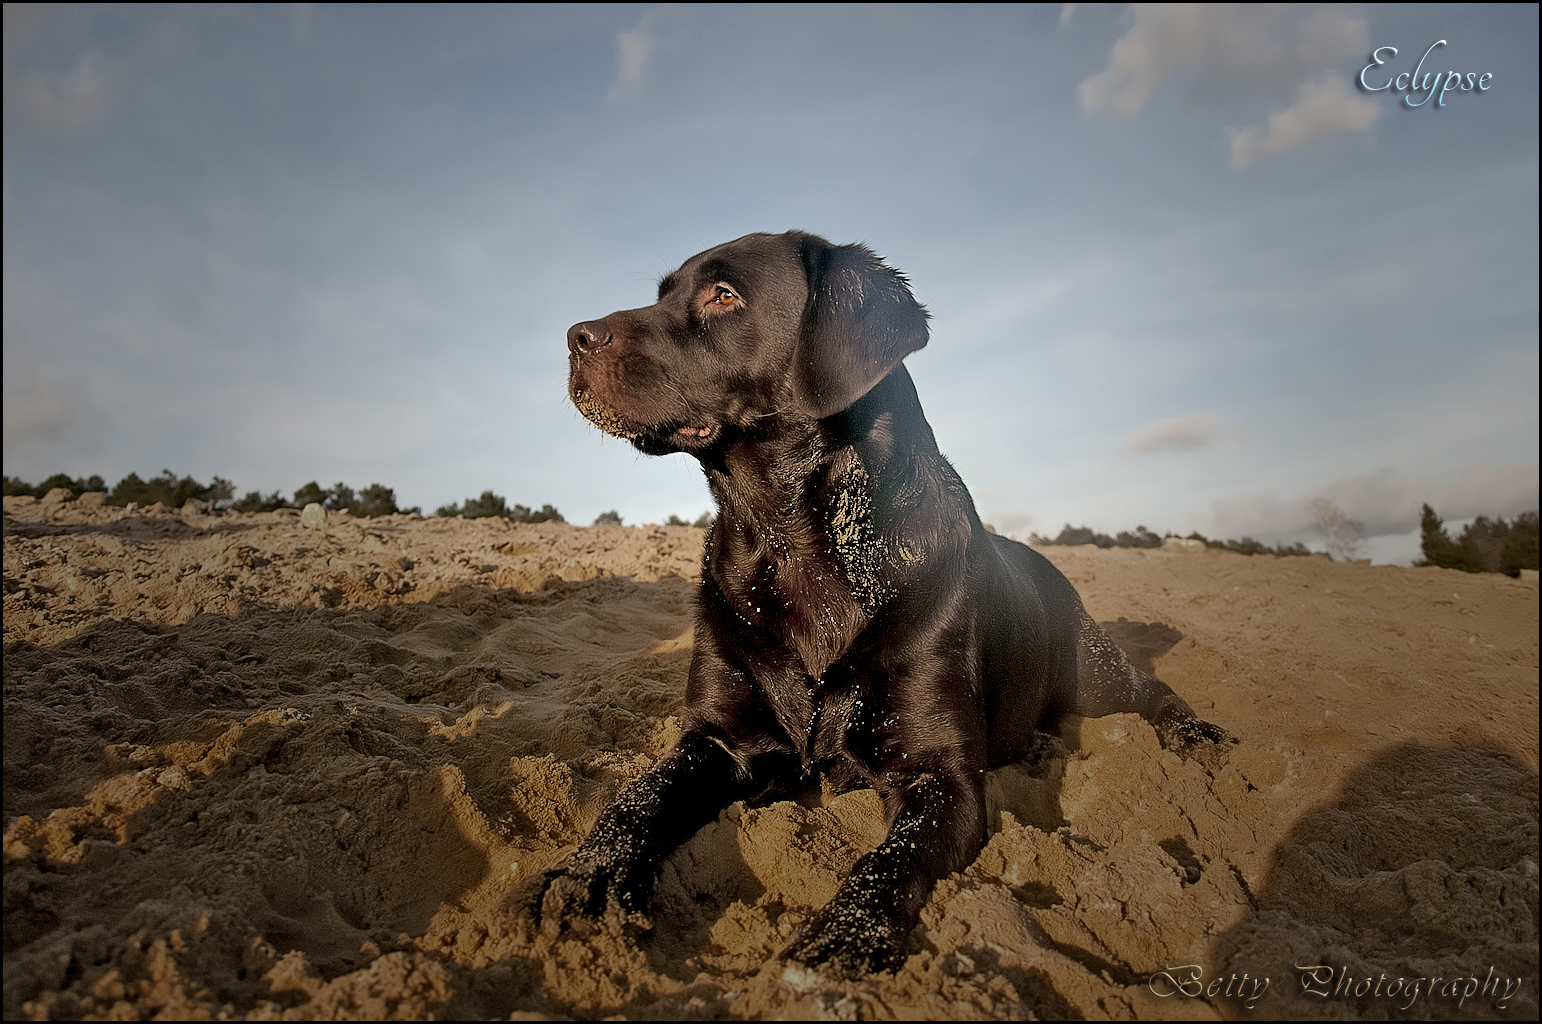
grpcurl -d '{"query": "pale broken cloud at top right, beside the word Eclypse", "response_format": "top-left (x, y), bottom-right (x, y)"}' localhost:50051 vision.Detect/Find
top-left (1078, 5), bottom-right (1380, 170)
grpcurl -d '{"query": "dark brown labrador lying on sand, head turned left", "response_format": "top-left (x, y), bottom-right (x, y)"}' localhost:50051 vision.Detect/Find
top-left (530, 231), bottom-right (1227, 976)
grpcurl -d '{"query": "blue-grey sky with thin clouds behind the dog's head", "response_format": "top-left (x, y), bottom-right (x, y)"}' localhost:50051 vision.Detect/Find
top-left (5, 5), bottom-right (1539, 560)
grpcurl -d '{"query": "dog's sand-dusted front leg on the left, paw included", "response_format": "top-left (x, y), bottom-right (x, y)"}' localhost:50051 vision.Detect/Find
top-left (513, 729), bottom-right (751, 939)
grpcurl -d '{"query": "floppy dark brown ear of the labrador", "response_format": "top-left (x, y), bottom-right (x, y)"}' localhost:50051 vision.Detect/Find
top-left (793, 236), bottom-right (927, 419)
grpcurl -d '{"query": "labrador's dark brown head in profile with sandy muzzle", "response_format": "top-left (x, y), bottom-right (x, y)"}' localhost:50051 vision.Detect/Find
top-left (567, 231), bottom-right (927, 455)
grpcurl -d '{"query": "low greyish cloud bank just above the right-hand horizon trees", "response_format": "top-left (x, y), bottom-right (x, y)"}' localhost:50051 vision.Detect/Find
top-left (1215, 460), bottom-right (1537, 540)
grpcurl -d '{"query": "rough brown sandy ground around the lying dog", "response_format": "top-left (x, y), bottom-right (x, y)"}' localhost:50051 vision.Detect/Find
top-left (5, 497), bottom-right (1537, 1019)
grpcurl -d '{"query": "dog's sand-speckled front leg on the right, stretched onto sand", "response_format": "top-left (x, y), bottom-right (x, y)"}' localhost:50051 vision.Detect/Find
top-left (782, 757), bottom-right (985, 978)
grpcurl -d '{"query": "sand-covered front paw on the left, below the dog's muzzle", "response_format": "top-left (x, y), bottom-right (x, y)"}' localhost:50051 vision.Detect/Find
top-left (509, 851), bottom-right (652, 939)
